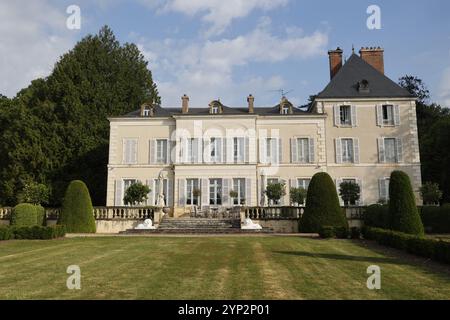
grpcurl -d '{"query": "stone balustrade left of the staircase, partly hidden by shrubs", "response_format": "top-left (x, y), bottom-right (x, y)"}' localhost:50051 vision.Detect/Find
top-left (0, 207), bottom-right (156, 220)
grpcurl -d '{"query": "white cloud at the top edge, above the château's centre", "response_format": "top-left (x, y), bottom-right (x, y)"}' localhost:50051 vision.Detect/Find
top-left (140, 0), bottom-right (289, 37)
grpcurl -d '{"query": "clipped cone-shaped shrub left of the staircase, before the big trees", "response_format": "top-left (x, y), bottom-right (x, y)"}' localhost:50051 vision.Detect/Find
top-left (58, 180), bottom-right (96, 233)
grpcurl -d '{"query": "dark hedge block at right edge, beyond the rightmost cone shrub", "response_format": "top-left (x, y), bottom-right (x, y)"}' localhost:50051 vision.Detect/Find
top-left (420, 204), bottom-right (450, 233)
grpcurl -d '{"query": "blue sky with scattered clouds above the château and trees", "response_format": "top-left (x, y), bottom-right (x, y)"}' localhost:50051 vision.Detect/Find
top-left (0, 0), bottom-right (450, 107)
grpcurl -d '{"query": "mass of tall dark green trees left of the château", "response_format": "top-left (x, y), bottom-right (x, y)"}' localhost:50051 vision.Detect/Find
top-left (0, 27), bottom-right (160, 206)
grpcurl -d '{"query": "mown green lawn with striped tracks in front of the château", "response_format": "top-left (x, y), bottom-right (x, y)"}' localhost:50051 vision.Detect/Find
top-left (0, 236), bottom-right (450, 299)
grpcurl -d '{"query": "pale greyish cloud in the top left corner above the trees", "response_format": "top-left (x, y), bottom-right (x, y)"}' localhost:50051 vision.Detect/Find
top-left (0, 0), bottom-right (73, 97)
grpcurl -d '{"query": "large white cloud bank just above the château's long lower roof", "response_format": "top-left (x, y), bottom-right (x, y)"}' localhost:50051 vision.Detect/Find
top-left (138, 20), bottom-right (328, 106)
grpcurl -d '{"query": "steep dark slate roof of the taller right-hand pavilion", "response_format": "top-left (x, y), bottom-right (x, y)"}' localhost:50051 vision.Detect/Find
top-left (317, 54), bottom-right (413, 99)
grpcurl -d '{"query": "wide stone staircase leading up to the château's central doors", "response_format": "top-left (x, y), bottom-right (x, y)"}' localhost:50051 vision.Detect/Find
top-left (121, 217), bottom-right (273, 234)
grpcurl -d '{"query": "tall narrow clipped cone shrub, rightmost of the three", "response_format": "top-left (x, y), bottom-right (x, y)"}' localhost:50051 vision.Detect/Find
top-left (389, 171), bottom-right (424, 236)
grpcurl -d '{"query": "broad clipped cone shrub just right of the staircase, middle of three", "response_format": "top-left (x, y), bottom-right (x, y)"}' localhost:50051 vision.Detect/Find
top-left (299, 172), bottom-right (348, 233)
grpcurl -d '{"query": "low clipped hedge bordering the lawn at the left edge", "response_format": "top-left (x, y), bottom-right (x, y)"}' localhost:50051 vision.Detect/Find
top-left (0, 225), bottom-right (66, 240)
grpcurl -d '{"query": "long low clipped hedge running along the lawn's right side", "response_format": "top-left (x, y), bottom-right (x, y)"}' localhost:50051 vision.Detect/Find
top-left (363, 227), bottom-right (450, 264)
